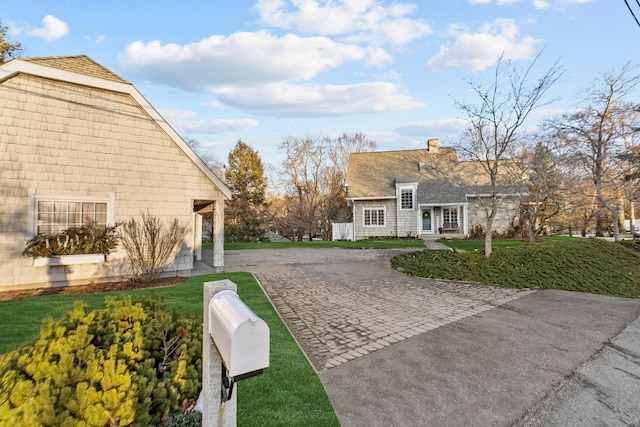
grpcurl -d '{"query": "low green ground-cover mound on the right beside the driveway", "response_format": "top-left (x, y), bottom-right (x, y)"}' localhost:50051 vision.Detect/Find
top-left (391, 238), bottom-right (640, 298)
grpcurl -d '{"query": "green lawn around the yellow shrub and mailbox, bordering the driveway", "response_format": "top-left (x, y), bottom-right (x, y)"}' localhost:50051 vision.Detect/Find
top-left (0, 273), bottom-right (339, 426)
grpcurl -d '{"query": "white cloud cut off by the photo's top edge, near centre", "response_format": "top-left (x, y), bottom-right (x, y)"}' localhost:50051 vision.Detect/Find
top-left (255, 0), bottom-right (432, 44)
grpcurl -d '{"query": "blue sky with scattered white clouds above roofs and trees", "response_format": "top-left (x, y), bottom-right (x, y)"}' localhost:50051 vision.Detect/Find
top-left (0, 0), bottom-right (640, 166)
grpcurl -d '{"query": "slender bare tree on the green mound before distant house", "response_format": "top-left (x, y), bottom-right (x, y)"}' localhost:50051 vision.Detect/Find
top-left (456, 54), bottom-right (562, 258)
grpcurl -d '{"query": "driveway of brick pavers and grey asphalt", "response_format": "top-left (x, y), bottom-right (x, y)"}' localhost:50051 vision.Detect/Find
top-left (225, 249), bottom-right (640, 426)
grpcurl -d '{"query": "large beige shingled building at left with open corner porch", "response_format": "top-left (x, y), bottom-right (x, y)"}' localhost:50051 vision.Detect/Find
top-left (0, 55), bottom-right (231, 291)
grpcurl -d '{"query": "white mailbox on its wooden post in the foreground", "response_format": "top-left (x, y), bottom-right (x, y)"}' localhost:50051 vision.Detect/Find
top-left (202, 280), bottom-right (269, 427)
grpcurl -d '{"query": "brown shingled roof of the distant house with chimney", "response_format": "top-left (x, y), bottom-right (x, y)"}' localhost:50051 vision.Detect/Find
top-left (345, 147), bottom-right (523, 204)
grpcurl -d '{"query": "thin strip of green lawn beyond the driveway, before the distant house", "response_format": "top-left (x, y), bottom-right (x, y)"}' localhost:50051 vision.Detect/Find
top-left (202, 239), bottom-right (424, 250)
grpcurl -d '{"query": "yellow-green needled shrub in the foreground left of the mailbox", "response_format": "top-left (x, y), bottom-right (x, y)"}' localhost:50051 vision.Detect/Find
top-left (0, 296), bottom-right (202, 427)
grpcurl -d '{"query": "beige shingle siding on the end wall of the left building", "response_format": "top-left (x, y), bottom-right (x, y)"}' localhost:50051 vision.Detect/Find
top-left (0, 74), bottom-right (223, 291)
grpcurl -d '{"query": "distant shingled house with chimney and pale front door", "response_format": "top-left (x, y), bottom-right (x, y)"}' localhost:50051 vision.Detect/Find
top-left (345, 139), bottom-right (525, 240)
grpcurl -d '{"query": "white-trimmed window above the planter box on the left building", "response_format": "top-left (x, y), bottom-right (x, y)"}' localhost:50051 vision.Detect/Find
top-left (35, 200), bottom-right (107, 234)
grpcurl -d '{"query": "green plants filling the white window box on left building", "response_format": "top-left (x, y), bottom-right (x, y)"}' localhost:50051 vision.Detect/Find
top-left (22, 222), bottom-right (118, 258)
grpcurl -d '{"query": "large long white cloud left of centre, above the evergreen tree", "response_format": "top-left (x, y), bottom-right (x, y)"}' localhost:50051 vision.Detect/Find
top-left (119, 31), bottom-right (390, 92)
